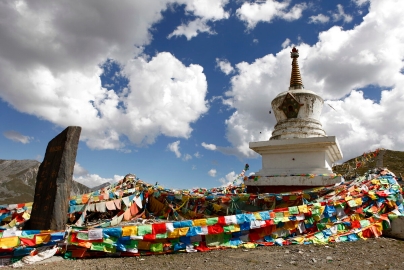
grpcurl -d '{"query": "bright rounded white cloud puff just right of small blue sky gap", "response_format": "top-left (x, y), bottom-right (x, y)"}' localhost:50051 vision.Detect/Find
top-left (120, 53), bottom-right (208, 147)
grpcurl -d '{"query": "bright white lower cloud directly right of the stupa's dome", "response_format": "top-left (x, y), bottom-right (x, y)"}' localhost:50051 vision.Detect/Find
top-left (322, 87), bottom-right (404, 159)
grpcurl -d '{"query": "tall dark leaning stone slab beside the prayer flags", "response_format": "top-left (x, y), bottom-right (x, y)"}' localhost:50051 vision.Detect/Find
top-left (28, 126), bottom-right (81, 230)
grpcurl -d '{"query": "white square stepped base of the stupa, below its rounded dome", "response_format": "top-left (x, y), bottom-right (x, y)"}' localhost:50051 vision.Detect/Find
top-left (245, 136), bottom-right (342, 193)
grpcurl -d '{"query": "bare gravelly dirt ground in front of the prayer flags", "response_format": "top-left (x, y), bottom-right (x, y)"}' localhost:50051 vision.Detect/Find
top-left (15, 237), bottom-right (404, 270)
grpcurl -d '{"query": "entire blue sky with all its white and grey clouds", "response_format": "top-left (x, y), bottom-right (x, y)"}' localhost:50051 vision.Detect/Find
top-left (0, 0), bottom-right (404, 189)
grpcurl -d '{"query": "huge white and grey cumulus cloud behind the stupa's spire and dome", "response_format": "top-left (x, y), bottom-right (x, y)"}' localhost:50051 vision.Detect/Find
top-left (221, 1), bottom-right (404, 158)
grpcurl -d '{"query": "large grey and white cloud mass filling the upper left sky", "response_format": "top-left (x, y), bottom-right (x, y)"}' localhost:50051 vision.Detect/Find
top-left (0, 0), bottom-right (208, 151)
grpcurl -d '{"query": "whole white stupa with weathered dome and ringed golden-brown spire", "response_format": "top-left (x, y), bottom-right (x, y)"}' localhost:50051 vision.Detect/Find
top-left (245, 48), bottom-right (342, 193)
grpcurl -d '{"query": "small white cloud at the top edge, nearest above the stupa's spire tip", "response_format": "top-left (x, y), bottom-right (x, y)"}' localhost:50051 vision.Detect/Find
top-left (236, 0), bottom-right (307, 29)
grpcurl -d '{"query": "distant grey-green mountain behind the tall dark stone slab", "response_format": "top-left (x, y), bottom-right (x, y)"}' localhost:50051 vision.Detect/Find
top-left (0, 159), bottom-right (90, 204)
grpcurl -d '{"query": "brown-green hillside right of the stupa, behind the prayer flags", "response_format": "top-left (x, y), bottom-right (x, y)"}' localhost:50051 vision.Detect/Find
top-left (333, 149), bottom-right (404, 179)
